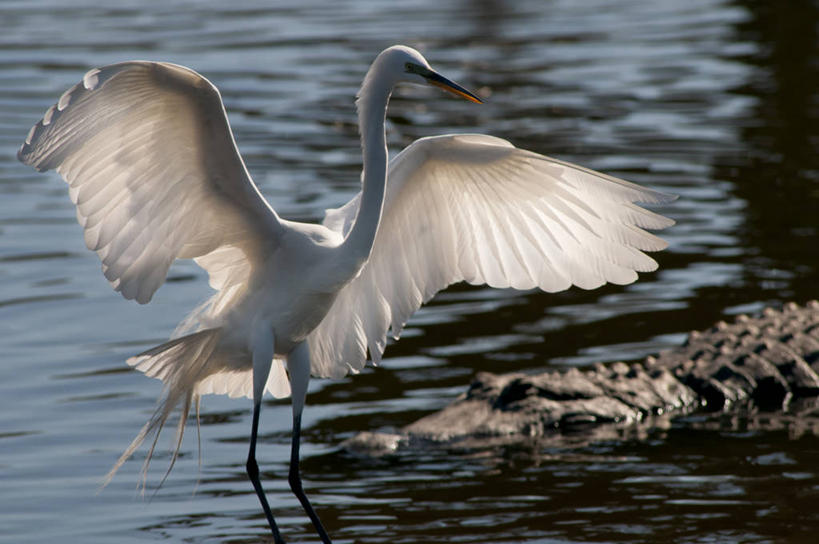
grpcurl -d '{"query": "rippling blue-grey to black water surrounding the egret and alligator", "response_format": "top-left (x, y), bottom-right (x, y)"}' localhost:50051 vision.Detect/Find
top-left (0, 0), bottom-right (819, 543)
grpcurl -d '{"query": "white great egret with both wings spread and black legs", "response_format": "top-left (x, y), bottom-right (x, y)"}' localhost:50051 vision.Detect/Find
top-left (17, 45), bottom-right (673, 543)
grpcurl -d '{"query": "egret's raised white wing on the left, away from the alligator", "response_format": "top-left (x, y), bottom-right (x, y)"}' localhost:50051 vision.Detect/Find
top-left (17, 61), bottom-right (279, 304)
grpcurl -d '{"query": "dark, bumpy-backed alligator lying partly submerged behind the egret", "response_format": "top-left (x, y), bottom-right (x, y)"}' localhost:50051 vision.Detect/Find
top-left (342, 301), bottom-right (819, 456)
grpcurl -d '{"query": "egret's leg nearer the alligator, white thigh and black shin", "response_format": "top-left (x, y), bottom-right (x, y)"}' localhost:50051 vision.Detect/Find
top-left (287, 342), bottom-right (332, 544)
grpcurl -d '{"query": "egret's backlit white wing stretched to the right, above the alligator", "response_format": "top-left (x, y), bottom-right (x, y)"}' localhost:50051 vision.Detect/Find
top-left (309, 134), bottom-right (674, 376)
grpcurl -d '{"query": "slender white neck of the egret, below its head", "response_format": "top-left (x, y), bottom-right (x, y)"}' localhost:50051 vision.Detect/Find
top-left (342, 69), bottom-right (392, 265)
